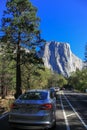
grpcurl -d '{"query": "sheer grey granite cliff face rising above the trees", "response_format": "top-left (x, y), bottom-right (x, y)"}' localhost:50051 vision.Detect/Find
top-left (38, 41), bottom-right (83, 77)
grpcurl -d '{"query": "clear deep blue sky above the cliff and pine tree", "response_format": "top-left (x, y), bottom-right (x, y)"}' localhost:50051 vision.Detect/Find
top-left (0, 0), bottom-right (87, 60)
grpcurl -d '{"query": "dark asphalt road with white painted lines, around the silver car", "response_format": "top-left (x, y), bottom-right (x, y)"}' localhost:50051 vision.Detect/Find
top-left (0, 91), bottom-right (87, 130)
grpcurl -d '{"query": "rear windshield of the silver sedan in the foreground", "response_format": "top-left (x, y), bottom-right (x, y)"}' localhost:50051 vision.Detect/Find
top-left (20, 92), bottom-right (47, 100)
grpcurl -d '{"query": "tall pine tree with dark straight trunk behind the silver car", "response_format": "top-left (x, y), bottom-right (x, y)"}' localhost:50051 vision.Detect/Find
top-left (1, 0), bottom-right (42, 98)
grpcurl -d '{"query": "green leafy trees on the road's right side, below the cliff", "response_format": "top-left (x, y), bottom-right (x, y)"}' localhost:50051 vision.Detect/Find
top-left (68, 68), bottom-right (87, 92)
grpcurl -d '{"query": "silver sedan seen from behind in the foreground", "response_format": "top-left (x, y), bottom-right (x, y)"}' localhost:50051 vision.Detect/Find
top-left (9, 90), bottom-right (56, 129)
